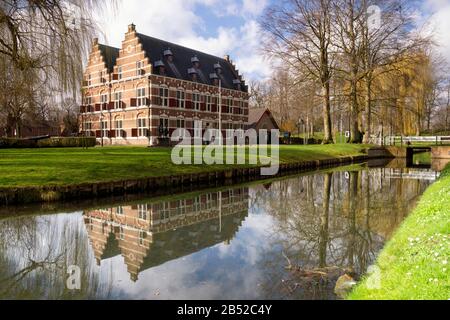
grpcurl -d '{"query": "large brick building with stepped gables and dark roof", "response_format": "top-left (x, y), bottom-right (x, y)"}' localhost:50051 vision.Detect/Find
top-left (80, 25), bottom-right (249, 146)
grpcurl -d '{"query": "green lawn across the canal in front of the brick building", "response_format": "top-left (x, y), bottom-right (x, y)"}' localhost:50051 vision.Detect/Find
top-left (0, 144), bottom-right (367, 188)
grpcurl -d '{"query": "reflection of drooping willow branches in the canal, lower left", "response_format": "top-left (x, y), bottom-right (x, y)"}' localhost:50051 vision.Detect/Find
top-left (0, 215), bottom-right (110, 299)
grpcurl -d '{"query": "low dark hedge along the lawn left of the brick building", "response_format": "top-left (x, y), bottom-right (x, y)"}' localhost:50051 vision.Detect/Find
top-left (0, 137), bottom-right (97, 149)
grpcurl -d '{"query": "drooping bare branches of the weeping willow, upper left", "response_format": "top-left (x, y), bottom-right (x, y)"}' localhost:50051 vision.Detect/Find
top-left (0, 0), bottom-right (115, 94)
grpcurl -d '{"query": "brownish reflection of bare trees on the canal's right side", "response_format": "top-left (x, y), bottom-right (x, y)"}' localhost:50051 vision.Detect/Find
top-left (255, 170), bottom-right (428, 299)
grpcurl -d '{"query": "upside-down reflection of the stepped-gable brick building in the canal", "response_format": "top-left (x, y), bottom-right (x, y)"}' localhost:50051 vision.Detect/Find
top-left (84, 188), bottom-right (248, 281)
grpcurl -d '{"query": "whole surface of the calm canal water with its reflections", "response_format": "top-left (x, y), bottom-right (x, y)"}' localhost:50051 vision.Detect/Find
top-left (0, 160), bottom-right (439, 299)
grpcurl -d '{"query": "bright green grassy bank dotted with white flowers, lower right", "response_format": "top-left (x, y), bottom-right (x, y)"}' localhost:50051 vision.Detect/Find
top-left (349, 165), bottom-right (450, 300)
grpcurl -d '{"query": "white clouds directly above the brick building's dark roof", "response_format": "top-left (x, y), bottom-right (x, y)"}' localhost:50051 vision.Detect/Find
top-left (95, 0), bottom-right (270, 80)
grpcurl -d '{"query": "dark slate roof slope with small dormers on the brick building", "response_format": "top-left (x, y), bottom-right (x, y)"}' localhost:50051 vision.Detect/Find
top-left (137, 33), bottom-right (247, 91)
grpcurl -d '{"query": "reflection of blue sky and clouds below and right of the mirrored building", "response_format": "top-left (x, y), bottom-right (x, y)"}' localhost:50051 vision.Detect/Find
top-left (89, 205), bottom-right (273, 300)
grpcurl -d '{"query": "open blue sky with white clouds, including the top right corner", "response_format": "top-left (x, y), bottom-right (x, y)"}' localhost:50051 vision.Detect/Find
top-left (99, 0), bottom-right (450, 80)
